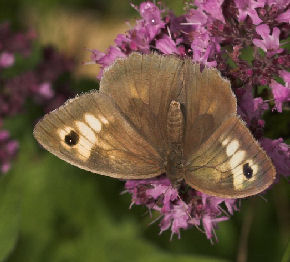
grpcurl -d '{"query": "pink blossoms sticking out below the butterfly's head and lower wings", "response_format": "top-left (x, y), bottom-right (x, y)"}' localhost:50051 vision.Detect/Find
top-left (125, 175), bottom-right (238, 242)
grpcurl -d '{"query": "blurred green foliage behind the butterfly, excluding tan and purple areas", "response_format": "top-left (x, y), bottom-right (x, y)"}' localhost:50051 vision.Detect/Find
top-left (0, 0), bottom-right (290, 262)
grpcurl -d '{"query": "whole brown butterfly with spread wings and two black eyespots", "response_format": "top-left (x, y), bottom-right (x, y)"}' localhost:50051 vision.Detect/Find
top-left (34, 53), bottom-right (276, 198)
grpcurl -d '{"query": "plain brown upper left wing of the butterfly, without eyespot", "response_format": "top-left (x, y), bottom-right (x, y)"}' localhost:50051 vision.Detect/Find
top-left (100, 53), bottom-right (183, 159)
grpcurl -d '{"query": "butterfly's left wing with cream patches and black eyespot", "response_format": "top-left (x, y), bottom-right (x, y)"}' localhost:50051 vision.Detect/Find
top-left (34, 91), bottom-right (164, 179)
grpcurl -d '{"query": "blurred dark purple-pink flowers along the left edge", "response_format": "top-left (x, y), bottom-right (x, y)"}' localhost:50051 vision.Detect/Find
top-left (0, 23), bottom-right (73, 174)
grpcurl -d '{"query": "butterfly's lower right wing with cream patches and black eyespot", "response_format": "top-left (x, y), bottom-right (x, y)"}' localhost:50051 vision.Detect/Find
top-left (185, 116), bottom-right (275, 198)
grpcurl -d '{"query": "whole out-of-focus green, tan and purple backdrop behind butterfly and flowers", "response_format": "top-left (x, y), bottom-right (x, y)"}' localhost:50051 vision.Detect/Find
top-left (0, 0), bottom-right (290, 262)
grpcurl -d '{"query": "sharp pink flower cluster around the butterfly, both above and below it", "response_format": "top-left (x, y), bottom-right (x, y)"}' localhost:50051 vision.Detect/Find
top-left (92, 0), bottom-right (290, 239)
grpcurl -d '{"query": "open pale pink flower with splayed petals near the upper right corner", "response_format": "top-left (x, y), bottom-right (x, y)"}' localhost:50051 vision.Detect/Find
top-left (253, 24), bottom-right (284, 56)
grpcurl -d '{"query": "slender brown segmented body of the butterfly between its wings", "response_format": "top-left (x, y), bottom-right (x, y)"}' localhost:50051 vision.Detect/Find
top-left (166, 101), bottom-right (184, 188)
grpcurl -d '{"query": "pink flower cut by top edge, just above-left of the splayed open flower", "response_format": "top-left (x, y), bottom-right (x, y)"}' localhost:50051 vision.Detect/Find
top-left (235, 0), bottom-right (264, 25)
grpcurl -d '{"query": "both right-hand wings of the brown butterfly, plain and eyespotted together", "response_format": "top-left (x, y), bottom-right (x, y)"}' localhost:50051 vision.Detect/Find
top-left (184, 61), bottom-right (276, 198)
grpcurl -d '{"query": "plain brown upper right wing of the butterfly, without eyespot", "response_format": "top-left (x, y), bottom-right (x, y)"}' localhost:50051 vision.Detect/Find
top-left (183, 60), bottom-right (237, 158)
